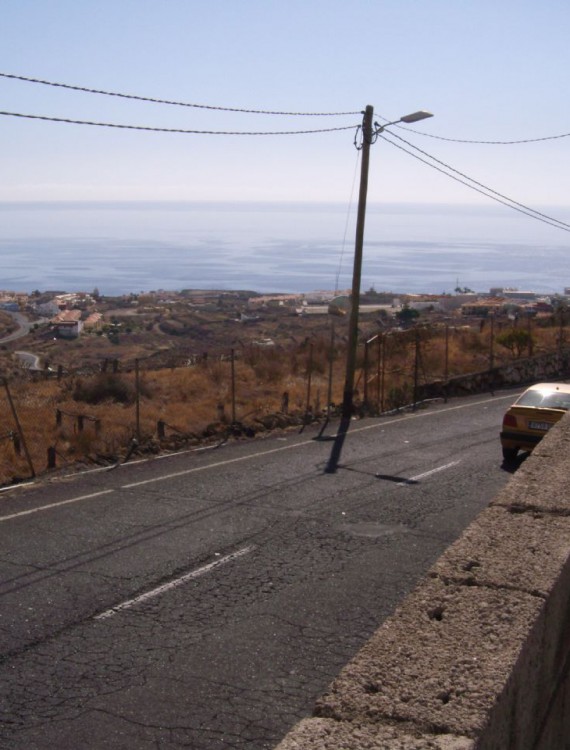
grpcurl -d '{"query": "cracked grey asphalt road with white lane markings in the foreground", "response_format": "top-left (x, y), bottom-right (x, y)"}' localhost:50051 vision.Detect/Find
top-left (0, 392), bottom-right (512, 750)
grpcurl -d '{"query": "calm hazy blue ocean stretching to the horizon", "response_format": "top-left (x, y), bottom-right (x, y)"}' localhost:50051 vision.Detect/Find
top-left (0, 202), bottom-right (570, 296)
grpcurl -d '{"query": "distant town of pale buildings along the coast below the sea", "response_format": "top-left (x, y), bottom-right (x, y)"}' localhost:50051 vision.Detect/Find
top-left (0, 286), bottom-right (570, 339)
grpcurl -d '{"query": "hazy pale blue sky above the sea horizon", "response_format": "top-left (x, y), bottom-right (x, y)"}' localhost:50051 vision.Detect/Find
top-left (0, 0), bottom-right (570, 217)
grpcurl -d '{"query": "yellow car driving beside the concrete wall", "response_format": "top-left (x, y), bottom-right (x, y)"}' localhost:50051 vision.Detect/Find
top-left (501, 383), bottom-right (570, 461)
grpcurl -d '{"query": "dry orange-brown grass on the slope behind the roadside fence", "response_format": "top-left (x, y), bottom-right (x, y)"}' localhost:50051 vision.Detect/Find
top-left (0, 327), bottom-right (560, 484)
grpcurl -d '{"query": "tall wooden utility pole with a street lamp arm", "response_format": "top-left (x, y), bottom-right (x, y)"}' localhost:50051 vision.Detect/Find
top-left (326, 104), bottom-right (433, 472)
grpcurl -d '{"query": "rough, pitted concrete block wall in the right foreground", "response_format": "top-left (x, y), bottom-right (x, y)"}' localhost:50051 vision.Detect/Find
top-left (277, 414), bottom-right (570, 750)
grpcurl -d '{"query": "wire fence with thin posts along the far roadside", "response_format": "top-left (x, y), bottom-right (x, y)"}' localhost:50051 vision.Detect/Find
top-left (0, 321), bottom-right (569, 484)
